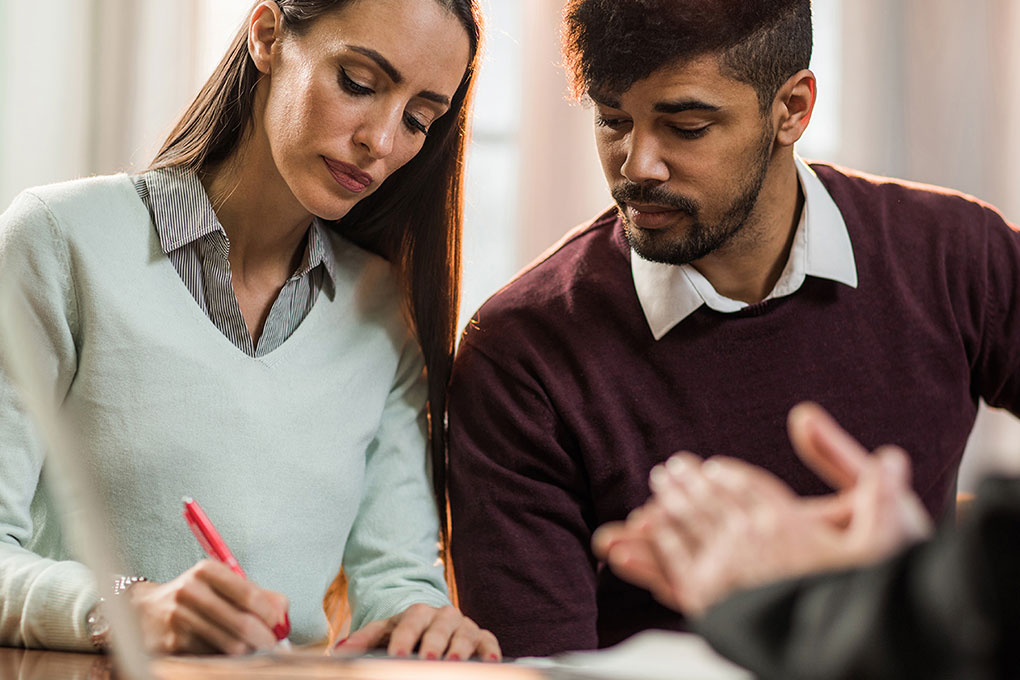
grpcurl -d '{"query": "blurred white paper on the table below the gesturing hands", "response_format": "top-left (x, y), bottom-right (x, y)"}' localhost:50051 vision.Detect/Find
top-left (516, 630), bottom-right (754, 680)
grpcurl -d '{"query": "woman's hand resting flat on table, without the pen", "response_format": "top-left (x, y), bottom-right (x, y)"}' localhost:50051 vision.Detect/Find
top-left (335, 604), bottom-right (503, 662)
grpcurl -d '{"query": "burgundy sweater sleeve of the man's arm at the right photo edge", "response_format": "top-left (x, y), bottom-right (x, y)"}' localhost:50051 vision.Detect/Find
top-left (974, 209), bottom-right (1020, 416)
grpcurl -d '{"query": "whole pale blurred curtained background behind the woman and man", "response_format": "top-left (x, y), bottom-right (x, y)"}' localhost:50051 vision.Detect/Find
top-left (0, 0), bottom-right (1020, 488)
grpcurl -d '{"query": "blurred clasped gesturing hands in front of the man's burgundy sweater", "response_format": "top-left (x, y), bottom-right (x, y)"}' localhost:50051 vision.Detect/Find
top-left (593, 404), bottom-right (931, 615)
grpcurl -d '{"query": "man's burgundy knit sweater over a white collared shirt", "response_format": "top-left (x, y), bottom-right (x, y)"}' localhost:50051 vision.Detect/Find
top-left (449, 165), bottom-right (1020, 657)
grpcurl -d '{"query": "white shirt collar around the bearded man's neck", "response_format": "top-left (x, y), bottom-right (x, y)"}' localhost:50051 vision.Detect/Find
top-left (630, 156), bottom-right (857, 339)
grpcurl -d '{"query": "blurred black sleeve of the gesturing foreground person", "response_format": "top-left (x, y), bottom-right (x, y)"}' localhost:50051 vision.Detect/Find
top-left (696, 479), bottom-right (1020, 680)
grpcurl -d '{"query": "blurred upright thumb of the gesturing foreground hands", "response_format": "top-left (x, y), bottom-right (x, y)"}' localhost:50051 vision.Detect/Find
top-left (787, 402), bottom-right (868, 489)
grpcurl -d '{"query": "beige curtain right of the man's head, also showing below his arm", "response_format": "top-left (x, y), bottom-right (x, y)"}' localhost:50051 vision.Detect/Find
top-left (828, 0), bottom-right (1020, 490)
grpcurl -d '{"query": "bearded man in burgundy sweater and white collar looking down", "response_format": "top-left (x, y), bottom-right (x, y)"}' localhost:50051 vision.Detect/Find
top-left (449, 0), bottom-right (1020, 656)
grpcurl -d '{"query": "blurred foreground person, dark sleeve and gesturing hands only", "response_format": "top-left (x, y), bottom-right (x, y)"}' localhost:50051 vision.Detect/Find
top-left (594, 405), bottom-right (1020, 680)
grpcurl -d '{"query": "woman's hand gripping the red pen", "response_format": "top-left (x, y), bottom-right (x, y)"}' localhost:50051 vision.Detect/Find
top-left (125, 560), bottom-right (291, 655)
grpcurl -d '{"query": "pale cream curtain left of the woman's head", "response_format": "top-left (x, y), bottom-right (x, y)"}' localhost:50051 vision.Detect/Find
top-left (0, 0), bottom-right (211, 207)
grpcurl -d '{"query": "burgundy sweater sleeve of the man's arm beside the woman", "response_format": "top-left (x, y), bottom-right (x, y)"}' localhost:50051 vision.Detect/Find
top-left (449, 332), bottom-right (595, 657)
